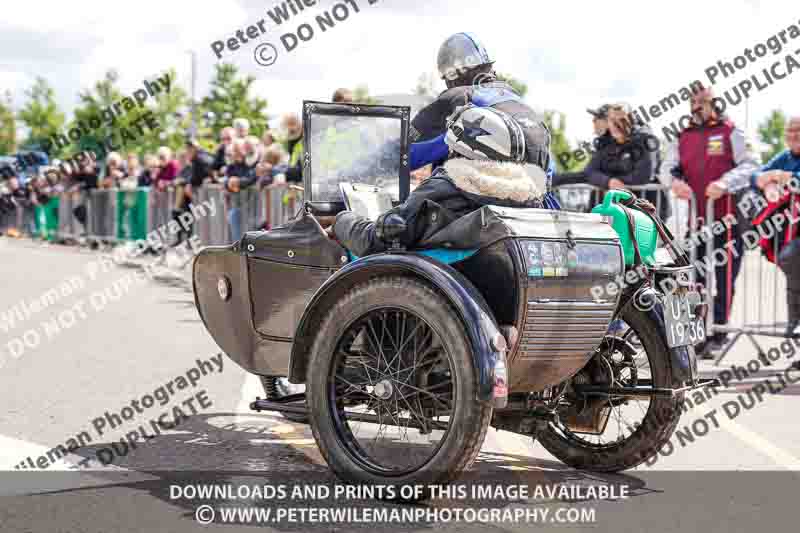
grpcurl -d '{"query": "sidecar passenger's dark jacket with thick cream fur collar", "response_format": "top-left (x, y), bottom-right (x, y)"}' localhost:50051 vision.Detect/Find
top-left (333, 158), bottom-right (547, 257)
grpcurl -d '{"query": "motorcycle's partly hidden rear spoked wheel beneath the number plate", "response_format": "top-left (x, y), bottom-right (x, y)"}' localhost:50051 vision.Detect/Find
top-left (536, 306), bottom-right (683, 472)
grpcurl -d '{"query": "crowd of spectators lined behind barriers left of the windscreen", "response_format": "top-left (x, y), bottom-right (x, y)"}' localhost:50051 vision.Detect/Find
top-left (0, 110), bottom-right (310, 240)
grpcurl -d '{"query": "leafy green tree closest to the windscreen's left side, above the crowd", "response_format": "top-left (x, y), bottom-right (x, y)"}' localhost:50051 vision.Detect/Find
top-left (198, 63), bottom-right (269, 139)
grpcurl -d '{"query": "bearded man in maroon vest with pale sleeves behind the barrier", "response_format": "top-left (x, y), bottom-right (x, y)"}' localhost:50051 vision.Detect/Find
top-left (662, 88), bottom-right (758, 357)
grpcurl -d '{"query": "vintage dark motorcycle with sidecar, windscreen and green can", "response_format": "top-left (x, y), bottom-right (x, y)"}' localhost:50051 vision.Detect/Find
top-left (193, 102), bottom-right (709, 485)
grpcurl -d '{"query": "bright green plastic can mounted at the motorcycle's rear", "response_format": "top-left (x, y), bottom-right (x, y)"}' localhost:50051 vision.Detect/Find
top-left (592, 190), bottom-right (658, 266)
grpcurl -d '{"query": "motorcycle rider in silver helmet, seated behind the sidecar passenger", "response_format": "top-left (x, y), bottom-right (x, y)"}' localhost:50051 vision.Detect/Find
top-left (409, 33), bottom-right (559, 209)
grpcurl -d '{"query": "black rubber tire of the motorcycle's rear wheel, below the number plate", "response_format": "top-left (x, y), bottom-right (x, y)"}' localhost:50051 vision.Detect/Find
top-left (536, 305), bottom-right (683, 472)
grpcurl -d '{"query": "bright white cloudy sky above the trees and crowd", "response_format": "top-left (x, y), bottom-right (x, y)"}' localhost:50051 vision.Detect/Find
top-left (0, 0), bottom-right (800, 145)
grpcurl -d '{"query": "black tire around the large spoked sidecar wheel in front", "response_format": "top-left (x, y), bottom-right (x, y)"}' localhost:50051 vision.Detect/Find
top-left (306, 276), bottom-right (492, 499)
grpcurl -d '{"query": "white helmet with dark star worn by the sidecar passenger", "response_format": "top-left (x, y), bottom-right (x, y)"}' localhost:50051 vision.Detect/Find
top-left (445, 105), bottom-right (525, 163)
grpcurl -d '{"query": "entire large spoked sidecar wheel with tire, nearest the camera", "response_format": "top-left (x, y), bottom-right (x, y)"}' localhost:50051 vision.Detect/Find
top-left (306, 277), bottom-right (492, 499)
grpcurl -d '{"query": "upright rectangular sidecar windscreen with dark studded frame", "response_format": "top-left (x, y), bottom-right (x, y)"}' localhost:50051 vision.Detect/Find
top-left (303, 102), bottom-right (410, 215)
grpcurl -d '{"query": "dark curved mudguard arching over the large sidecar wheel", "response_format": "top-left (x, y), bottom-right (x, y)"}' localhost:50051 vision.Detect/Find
top-left (289, 252), bottom-right (500, 401)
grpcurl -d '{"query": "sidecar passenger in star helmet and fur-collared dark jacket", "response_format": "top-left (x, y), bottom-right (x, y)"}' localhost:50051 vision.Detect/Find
top-left (331, 105), bottom-right (548, 257)
